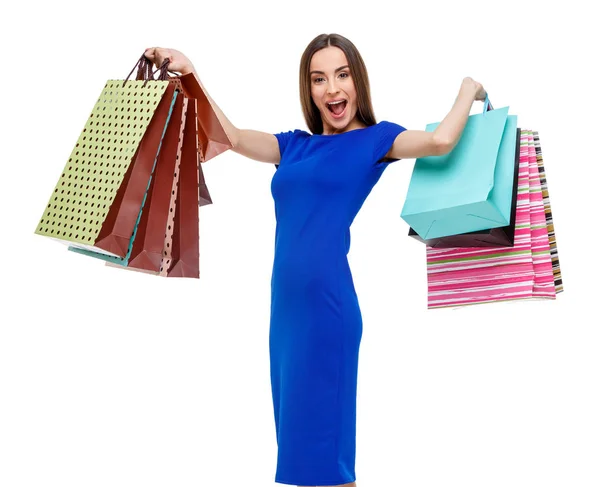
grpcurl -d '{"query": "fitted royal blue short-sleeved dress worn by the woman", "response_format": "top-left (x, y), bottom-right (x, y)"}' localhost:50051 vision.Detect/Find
top-left (269, 121), bottom-right (405, 486)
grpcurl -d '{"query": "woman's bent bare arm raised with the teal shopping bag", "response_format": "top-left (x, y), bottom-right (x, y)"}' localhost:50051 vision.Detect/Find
top-left (386, 78), bottom-right (485, 159)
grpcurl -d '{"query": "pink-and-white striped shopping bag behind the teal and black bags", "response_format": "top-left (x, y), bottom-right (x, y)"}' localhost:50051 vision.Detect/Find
top-left (426, 130), bottom-right (562, 308)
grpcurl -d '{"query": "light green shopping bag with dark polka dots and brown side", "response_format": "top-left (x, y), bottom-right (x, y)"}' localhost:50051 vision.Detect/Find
top-left (35, 54), bottom-right (175, 258)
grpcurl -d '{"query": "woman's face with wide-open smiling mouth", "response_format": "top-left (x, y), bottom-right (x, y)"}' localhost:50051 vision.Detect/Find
top-left (309, 46), bottom-right (363, 135)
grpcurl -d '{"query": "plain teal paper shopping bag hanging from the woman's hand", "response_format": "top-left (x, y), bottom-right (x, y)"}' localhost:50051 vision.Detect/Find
top-left (401, 98), bottom-right (517, 239)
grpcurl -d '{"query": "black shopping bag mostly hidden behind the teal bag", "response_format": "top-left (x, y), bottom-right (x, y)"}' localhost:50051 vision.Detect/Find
top-left (408, 128), bottom-right (521, 248)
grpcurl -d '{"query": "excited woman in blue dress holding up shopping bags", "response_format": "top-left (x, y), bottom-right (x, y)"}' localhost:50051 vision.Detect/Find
top-left (146, 34), bottom-right (485, 487)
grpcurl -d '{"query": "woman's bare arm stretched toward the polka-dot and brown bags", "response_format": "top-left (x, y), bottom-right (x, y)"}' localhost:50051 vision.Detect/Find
top-left (144, 47), bottom-right (281, 164)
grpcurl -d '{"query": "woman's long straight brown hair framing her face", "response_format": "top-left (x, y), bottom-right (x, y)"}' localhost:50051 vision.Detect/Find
top-left (300, 34), bottom-right (377, 134)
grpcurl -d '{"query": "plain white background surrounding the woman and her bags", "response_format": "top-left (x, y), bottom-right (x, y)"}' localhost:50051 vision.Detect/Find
top-left (0, 0), bottom-right (600, 487)
